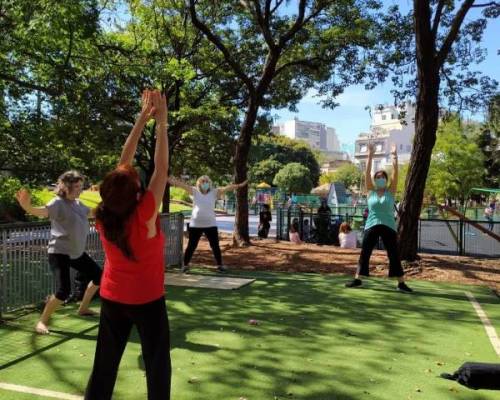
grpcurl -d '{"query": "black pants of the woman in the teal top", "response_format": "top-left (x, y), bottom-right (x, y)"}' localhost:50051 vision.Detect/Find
top-left (358, 225), bottom-right (404, 277)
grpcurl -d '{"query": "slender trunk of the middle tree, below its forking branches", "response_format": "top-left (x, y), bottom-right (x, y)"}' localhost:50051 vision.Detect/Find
top-left (233, 99), bottom-right (258, 246)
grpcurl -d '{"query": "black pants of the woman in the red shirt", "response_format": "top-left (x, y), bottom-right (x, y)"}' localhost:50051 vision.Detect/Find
top-left (85, 297), bottom-right (172, 400)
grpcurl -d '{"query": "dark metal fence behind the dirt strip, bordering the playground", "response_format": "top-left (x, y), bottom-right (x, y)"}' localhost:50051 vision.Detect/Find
top-left (276, 206), bottom-right (500, 258)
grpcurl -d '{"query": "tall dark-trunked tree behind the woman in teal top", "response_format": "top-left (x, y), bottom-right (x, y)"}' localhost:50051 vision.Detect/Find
top-left (392, 0), bottom-right (500, 261)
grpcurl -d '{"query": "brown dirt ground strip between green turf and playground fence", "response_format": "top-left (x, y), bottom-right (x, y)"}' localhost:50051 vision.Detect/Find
top-left (185, 234), bottom-right (500, 294)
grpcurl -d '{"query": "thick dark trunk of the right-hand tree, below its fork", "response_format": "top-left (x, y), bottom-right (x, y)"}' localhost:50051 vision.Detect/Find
top-left (399, 68), bottom-right (439, 261)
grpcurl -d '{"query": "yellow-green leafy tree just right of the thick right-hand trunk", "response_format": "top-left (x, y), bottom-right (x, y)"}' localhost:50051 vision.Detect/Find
top-left (426, 117), bottom-right (484, 200)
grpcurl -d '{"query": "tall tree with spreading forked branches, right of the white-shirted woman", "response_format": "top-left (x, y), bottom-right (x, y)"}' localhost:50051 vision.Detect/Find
top-left (186, 0), bottom-right (380, 244)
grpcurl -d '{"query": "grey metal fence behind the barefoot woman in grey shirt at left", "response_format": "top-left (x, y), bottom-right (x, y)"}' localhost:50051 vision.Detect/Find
top-left (0, 213), bottom-right (184, 316)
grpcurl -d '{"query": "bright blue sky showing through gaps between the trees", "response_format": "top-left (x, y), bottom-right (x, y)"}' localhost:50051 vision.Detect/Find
top-left (272, 0), bottom-right (500, 150)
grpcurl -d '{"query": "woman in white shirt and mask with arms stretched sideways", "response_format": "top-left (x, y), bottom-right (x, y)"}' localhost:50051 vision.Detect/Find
top-left (168, 175), bottom-right (247, 272)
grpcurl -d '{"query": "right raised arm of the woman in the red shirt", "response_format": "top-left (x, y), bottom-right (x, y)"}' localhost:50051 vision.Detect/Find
top-left (148, 91), bottom-right (168, 209)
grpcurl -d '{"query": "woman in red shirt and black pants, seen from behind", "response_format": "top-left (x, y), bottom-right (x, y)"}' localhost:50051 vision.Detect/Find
top-left (85, 91), bottom-right (171, 400)
